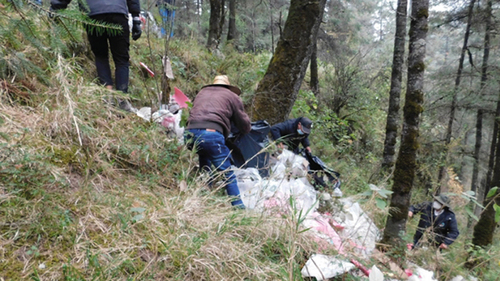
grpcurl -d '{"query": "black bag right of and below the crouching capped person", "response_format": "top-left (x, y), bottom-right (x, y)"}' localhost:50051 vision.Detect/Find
top-left (302, 151), bottom-right (341, 190)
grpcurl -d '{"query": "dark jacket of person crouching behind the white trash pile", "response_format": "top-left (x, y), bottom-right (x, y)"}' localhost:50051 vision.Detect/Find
top-left (271, 117), bottom-right (311, 153)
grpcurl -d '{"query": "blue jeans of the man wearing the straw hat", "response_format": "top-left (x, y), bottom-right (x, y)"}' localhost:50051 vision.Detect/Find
top-left (184, 129), bottom-right (244, 207)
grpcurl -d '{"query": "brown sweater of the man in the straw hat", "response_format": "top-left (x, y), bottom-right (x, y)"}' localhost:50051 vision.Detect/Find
top-left (187, 86), bottom-right (251, 137)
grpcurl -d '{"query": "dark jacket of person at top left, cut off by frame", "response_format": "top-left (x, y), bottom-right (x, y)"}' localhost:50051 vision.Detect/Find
top-left (50, 0), bottom-right (141, 17)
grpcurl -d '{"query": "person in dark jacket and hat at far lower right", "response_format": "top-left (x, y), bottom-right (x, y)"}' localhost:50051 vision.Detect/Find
top-left (408, 194), bottom-right (460, 249)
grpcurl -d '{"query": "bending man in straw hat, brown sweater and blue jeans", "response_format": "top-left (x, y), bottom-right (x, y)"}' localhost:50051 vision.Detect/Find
top-left (184, 75), bottom-right (251, 208)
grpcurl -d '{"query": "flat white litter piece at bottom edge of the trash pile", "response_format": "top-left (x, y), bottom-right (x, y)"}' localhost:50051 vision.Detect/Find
top-left (300, 254), bottom-right (355, 280)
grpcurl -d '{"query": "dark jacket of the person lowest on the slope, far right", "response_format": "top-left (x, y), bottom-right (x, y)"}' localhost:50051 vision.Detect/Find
top-left (409, 202), bottom-right (460, 246)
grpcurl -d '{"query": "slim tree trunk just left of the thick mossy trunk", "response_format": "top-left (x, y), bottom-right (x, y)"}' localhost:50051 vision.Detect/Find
top-left (382, 0), bottom-right (408, 169)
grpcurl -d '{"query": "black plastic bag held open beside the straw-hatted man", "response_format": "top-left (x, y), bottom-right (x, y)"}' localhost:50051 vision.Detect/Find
top-left (226, 120), bottom-right (271, 177)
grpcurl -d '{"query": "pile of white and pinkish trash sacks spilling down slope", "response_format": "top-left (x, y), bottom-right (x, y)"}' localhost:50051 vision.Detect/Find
top-left (234, 150), bottom-right (460, 281)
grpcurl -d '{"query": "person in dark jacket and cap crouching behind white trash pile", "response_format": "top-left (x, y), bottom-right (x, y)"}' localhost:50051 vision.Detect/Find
top-left (271, 117), bottom-right (312, 154)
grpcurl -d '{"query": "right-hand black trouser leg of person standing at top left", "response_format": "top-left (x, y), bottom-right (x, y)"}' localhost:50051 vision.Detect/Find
top-left (109, 14), bottom-right (130, 93)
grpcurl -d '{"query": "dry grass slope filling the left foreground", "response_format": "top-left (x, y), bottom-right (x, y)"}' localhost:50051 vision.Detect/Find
top-left (0, 53), bottom-right (322, 280)
